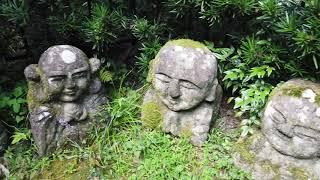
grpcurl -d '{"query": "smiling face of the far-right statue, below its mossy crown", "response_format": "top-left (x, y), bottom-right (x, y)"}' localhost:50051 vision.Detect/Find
top-left (263, 96), bottom-right (320, 158)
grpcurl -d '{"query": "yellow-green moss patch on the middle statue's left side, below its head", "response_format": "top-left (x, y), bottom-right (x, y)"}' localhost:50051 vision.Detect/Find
top-left (141, 102), bottom-right (163, 129)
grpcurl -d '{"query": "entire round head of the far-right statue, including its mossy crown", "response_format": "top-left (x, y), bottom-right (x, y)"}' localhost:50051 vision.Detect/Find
top-left (262, 80), bottom-right (320, 158)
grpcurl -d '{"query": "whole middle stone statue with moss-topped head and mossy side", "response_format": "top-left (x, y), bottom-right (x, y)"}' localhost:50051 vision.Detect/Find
top-left (142, 39), bottom-right (222, 146)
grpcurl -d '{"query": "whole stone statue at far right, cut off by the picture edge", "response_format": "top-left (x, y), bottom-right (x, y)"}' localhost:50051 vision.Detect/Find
top-left (237, 79), bottom-right (320, 179)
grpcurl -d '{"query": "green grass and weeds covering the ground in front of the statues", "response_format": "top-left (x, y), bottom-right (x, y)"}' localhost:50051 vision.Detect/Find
top-left (5, 87), bottom-right (250, 179)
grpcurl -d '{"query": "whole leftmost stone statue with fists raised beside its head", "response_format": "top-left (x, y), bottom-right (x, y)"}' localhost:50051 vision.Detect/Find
top-left (25, 45), bottom-right (107, 155)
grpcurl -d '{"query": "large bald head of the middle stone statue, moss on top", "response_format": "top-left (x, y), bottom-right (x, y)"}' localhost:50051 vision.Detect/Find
top-left (149, 40), bottom-right (217, 111)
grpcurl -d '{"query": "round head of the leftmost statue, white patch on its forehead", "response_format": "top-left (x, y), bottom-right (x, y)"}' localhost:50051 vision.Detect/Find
top-left (39, 46), bottom-right (90, 102)
